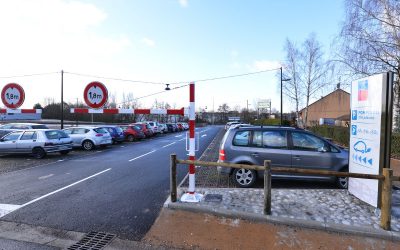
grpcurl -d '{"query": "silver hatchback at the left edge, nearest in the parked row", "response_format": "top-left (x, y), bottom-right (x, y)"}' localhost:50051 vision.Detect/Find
top-left (0, 129), bottom-right (72, 159)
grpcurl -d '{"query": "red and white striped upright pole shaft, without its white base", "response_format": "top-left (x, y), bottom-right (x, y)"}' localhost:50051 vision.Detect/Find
top-left (188, 82), bottom-right (196, 194)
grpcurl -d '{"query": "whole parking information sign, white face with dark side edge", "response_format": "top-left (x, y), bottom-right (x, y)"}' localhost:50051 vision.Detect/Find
top-left (348, 72), bottom-right (393, 207)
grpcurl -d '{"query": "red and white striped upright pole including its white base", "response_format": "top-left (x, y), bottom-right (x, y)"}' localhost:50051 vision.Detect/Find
top-left (181, 82), bottom-right (202, 202)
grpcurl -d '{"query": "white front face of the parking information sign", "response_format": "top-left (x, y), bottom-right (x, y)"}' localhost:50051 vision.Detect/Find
top-left (349, 74), bottom-right (384, 207)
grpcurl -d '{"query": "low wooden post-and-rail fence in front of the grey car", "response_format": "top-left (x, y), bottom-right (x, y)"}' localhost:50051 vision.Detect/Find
top-left (170, 154), bottom-right (400, 230)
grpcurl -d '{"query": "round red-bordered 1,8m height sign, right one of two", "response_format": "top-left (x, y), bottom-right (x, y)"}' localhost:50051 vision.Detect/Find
top-left (83, 82), bottom-right (108, 109)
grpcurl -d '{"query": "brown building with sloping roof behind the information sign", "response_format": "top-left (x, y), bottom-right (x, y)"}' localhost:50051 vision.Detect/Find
top-left (299, 88), bottom-right (350, 126)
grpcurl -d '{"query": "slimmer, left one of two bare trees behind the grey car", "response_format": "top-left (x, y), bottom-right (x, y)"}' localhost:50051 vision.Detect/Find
top-left (279, 39), bottom-right (302, 118)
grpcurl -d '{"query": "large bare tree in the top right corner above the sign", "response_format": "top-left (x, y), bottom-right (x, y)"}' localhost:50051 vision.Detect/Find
top-left (337, 0), bottom-right (400, 131)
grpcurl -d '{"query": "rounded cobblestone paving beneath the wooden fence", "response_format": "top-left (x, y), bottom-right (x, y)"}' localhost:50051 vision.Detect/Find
top-left (180, 188), bottom-right (400, 232)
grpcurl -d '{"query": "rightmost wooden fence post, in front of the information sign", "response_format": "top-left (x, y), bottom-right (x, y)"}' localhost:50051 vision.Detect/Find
top-left (381, 168), bottom-right (393, 230)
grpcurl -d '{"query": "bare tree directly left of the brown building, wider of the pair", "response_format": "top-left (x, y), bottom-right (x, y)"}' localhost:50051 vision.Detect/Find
top-left (300, 34), bottom-right (331, 126)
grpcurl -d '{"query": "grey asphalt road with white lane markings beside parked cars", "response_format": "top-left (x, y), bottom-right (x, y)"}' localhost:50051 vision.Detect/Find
top-left (0, 127), bottom-right (220, 240)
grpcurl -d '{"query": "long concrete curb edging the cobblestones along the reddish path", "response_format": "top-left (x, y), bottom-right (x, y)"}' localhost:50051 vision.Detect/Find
top-left (164, 199), bottom-right (400, 241)
